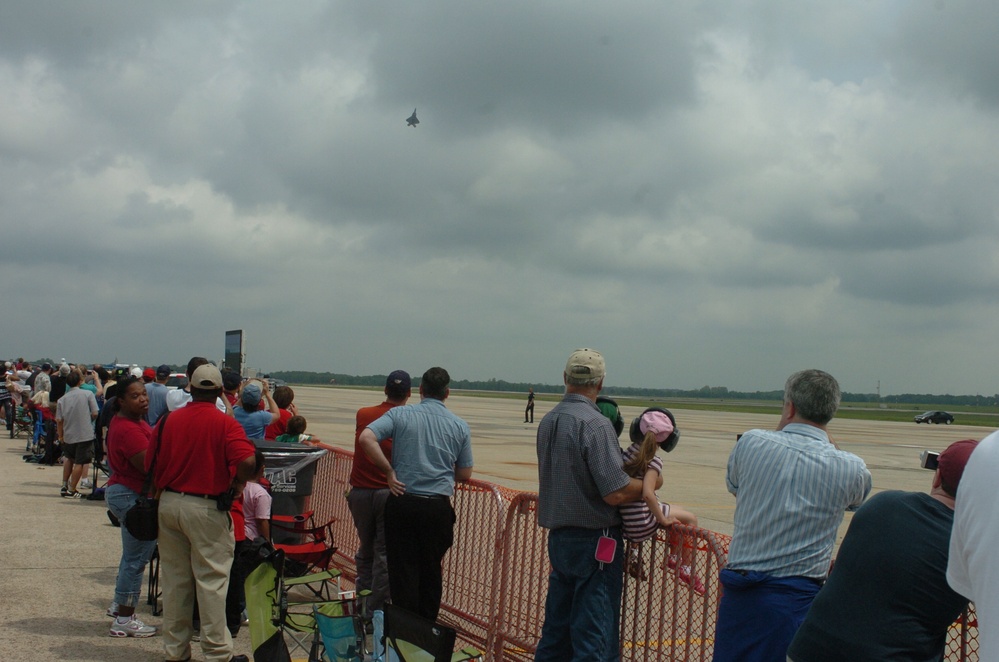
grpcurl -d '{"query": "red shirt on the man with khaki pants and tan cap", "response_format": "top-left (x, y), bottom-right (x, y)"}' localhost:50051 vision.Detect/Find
top-left (146, 401), bottom-right (256, 495)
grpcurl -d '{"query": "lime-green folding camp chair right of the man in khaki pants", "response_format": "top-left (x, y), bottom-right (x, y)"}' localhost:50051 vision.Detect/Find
top-left (245, 549), bottom-right (363, 662)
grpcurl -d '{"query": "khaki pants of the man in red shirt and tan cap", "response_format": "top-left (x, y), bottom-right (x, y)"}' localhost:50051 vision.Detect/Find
top-left (159, 492), bottom-right (235, 662)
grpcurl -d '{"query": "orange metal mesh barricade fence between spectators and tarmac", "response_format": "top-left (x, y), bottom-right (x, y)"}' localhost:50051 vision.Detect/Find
top-left (310, 446), bottom-right (978, 662)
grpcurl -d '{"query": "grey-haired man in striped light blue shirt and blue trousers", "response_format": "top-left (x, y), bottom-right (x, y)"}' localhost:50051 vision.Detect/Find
top-left (714, 370), bottom-right (871, 662)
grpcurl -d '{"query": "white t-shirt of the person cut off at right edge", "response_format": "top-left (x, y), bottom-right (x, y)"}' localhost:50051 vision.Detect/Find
top-left (947, 432), bottom-right (999, 660)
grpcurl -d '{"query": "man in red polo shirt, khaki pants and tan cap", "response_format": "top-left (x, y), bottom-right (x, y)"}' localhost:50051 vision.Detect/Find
top-left (146, 364), bottom-right (255, 662)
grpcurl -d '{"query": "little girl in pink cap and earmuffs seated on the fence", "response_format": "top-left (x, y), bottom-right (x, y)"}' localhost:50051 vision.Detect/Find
top-left (620, 407), bottom-right (705, 595)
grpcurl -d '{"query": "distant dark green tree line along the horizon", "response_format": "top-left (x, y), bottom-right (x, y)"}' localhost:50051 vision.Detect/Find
top-left (270, 370), bottom-right (999, 406)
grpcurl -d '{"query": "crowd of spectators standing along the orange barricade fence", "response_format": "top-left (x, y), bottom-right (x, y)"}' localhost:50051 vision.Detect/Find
top-left (0, 349), bottom-right (999, 662)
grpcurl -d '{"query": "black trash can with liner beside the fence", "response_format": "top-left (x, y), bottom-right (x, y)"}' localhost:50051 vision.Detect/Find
top-left (253, 439), bottom-right (326, 544)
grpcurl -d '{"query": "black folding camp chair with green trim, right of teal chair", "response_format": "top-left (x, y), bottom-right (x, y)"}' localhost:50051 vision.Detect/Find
top-left (385, 604), bottom-right (483, 662)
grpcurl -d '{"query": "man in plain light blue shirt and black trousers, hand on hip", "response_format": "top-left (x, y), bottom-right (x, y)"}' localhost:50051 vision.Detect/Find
top-left (357, 368), bottom-right (472, 620)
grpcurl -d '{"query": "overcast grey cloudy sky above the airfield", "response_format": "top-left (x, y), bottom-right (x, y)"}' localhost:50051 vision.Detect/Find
top-left (0, 0), bottom-right (999, 394)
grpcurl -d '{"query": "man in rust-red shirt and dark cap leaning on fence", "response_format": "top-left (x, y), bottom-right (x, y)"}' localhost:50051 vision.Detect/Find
top-left (347, 370), bottom-right (412, 610)
